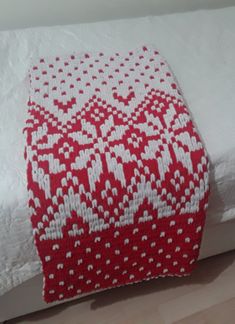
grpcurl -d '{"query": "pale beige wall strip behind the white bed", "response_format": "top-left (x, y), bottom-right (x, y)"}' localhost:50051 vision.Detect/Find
top-left (0, 0), bottom-right (235, 30)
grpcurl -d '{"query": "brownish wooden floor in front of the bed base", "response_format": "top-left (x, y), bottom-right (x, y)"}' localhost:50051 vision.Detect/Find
top-left (7, 252), bottom-right (235, 324)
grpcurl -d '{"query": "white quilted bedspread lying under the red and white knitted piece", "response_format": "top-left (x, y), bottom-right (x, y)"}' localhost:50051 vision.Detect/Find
top-left (0, 7), bottom-right (235, 295)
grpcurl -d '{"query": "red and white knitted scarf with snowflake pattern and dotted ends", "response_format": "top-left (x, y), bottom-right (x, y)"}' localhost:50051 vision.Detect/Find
top-left (26, 47), bottom-right (208, 302)
